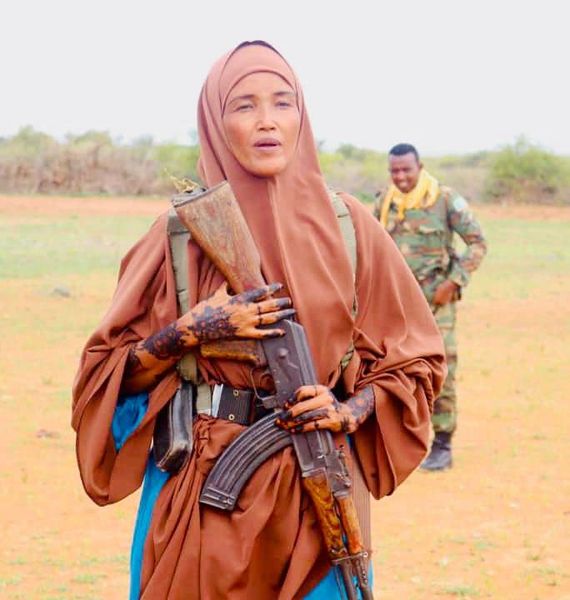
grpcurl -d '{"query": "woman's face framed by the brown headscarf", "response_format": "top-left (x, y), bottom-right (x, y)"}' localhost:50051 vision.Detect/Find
top-left (223, 73), bottom-right (301, 177)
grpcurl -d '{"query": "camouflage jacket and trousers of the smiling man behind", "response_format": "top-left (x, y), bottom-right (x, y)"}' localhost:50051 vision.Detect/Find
top-left (375, 186), bottom-right (487, 433)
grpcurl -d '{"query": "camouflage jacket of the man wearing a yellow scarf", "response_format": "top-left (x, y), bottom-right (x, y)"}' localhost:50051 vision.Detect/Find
top-left (374, 186), bottom-right (487, 303)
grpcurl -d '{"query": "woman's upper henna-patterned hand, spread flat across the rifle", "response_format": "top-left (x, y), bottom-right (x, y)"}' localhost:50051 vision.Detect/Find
top-left (176, 282), bottom-right (295, 346)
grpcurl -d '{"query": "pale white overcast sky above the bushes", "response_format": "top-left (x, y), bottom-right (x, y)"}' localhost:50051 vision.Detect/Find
top-left (0, 0), bottom-right (570, 155)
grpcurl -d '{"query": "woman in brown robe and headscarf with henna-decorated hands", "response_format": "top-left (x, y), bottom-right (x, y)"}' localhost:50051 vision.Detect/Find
top-left (73, 42), bottom-right (444, 599)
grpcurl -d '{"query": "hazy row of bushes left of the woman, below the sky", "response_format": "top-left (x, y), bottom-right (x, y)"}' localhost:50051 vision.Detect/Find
top-left (0, 127), bottom-right (199, 195)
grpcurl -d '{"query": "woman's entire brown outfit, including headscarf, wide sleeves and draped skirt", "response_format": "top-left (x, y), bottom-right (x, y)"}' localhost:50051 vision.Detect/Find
top-left (72, 39), bottom-right (445, 600)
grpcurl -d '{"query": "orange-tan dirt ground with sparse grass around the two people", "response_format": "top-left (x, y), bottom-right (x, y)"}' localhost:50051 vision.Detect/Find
top-left (0, 197), bottom-right (570, 600)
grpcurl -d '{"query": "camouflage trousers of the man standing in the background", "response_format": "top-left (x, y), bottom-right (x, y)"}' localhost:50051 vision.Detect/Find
top-left (431, 302), bottom-right (457, 433)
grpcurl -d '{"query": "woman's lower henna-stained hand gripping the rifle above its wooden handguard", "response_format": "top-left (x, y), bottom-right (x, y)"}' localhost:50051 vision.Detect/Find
top-left (277, 385), bottom-right (374, 433)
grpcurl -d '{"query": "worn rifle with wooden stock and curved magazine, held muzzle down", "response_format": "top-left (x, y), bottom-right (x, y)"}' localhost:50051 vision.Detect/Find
top-left (172, 182), bottom-right (373, 600)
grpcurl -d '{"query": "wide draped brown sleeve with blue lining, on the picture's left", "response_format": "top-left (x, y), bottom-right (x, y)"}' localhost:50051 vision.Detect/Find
top-left (72, 213), bottom-right (177, 505)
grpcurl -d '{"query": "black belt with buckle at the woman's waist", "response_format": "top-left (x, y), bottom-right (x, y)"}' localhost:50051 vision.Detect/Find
top-left (198, 384), bottom-right (270, 425)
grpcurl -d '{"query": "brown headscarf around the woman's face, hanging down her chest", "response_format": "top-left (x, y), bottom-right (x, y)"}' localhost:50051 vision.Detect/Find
top-left (198, 44), bottom-right (354, 384)
